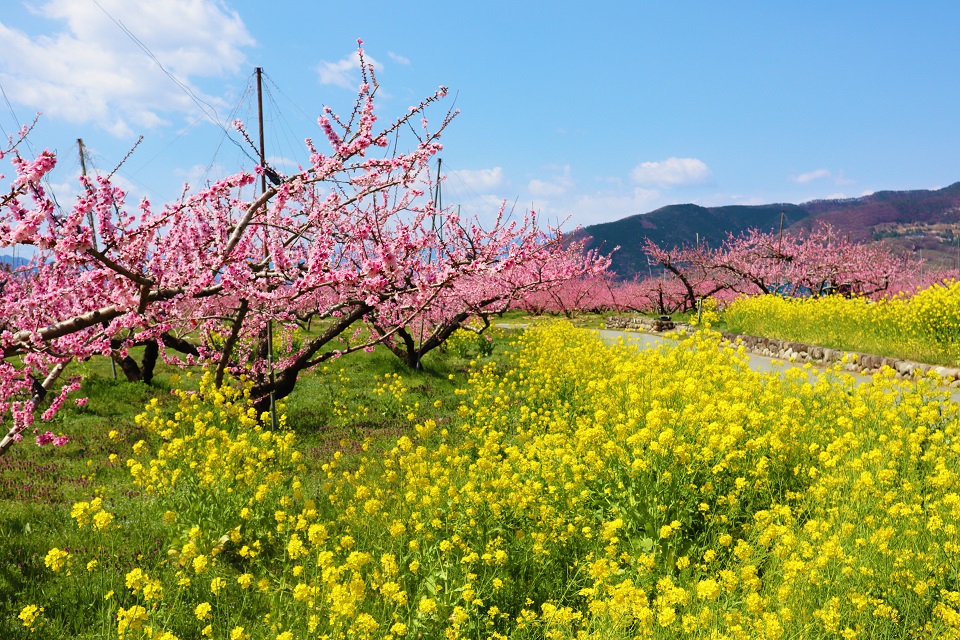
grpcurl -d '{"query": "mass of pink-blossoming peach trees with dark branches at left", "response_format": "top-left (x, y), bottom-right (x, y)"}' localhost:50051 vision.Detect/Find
top-left (0, 43), bottom-right (606, 455)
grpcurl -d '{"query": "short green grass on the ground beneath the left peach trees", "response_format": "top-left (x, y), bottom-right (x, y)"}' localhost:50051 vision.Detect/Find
top-left (0, 331), bottom-right (510, 640)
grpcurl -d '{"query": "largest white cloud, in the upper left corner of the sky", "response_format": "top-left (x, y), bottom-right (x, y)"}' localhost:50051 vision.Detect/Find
top-left (0, 0), bottom-right (254, 136)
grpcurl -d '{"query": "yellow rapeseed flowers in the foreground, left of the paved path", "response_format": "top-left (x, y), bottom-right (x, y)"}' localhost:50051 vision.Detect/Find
top-left (54, 323), bottom-right (960, 640)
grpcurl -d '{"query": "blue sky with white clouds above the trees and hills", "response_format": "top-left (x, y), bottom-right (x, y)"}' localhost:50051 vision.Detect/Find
top-left (0, 0), bottom-right (960, 229)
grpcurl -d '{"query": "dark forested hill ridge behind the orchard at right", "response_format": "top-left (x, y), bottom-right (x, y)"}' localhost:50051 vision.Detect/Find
top-left (575, 182), bottom-right (960, 278)
